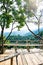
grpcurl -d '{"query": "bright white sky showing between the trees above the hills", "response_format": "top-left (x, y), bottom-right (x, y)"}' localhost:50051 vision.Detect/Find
top-left (0, 1), bottom-right (43, 32)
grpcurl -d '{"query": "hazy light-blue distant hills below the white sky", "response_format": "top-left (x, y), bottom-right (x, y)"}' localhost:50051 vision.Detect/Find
top-left (4, 28), bottom-right (43, 36)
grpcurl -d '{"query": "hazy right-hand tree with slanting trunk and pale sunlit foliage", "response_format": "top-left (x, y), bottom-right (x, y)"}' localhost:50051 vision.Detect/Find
top-left (25, 0), bottom-right (43, 40)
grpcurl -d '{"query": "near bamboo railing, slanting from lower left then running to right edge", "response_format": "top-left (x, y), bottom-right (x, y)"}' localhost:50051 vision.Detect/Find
top-left (0, 51), bottom-right (43, 65)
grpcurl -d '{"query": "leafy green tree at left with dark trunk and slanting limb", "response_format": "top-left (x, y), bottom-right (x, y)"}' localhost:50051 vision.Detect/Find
top-left (0, 0), bottom-right (26, 53)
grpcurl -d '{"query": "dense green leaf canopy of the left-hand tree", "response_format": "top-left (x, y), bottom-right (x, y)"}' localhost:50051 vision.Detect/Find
top-left (0, 0), bottom-right (26, 28)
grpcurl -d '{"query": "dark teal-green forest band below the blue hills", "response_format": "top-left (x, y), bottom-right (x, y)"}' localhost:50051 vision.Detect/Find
top-left (7, 31), bottom-right (43, 43)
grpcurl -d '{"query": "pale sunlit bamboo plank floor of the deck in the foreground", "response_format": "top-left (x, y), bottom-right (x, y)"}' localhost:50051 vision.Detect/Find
top-left (0, 48), bottom-right (43, 65)
